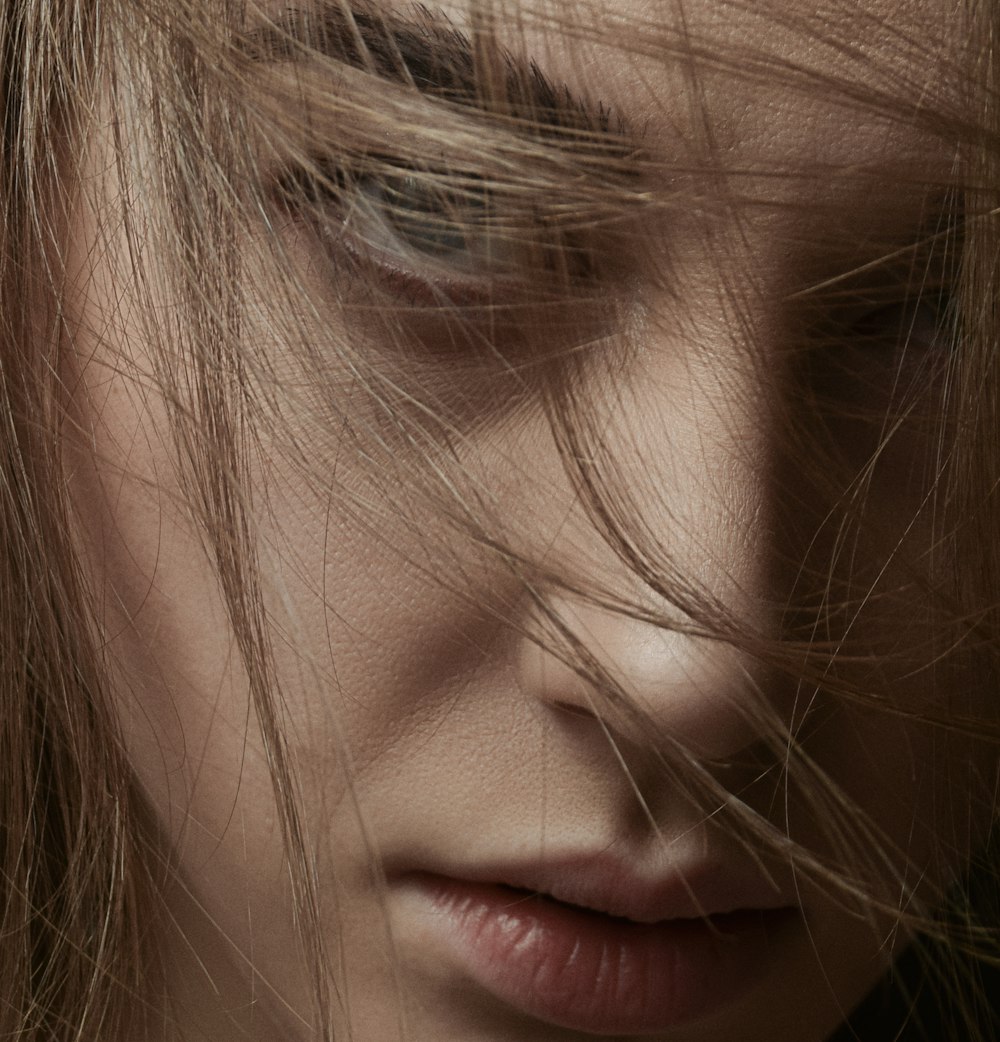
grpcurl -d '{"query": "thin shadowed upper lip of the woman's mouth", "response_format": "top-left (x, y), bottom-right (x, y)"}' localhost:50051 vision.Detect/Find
top-left (397, 852), bottom-right (796, 923)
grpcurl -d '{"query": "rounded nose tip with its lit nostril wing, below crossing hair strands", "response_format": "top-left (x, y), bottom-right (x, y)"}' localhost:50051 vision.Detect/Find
top-left (520, 603), bottom-right (781, 762)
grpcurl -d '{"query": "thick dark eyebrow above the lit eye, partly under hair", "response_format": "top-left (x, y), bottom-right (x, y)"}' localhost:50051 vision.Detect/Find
top-left (246, 0), bottom-right (634, 142)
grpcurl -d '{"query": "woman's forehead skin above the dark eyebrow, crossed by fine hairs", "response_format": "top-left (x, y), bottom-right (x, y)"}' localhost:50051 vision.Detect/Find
top-left (258, 0), bottom-right (969, 170)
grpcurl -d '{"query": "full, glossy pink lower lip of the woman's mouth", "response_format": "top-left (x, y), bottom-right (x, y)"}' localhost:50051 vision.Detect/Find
top-left (417, 876), bottom-right (795, 1035)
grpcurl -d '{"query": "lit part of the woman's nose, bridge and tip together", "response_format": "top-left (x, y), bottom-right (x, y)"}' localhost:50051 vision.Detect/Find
top-left (521, 298), bottom-right (775, 759)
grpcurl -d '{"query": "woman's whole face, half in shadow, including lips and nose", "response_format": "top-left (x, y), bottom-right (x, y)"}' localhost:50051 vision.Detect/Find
top-left (64, 0), bottom-right (982, 1042)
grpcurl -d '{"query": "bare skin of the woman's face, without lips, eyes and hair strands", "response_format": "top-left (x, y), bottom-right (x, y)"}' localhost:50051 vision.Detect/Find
top-left (67, 0), bottom-right (981, 1042)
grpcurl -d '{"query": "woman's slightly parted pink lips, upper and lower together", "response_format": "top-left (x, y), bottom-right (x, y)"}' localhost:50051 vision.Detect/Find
top-left (400, 858), bottom-right (799, 1035)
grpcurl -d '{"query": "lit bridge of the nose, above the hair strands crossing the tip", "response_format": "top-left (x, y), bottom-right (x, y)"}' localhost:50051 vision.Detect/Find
top-left (566, 283), bottom-right (781, 616)
